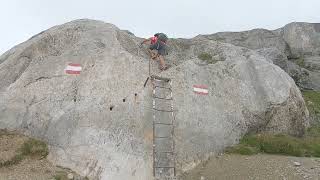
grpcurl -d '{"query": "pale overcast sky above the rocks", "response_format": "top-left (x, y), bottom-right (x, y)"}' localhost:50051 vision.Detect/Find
top-left (0, 0), bottom-right (320, 54)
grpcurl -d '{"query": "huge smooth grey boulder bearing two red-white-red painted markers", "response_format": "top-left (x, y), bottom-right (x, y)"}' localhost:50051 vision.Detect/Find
top-left (0, 20), bottom-right (309, 180)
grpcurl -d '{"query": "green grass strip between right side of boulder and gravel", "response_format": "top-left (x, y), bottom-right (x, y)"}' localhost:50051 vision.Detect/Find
top-left (226, 91), bottom-right (320, 157)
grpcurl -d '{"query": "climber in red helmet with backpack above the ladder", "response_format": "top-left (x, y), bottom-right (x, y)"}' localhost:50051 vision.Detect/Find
top-left (141, 33), bottom-right (168, 70)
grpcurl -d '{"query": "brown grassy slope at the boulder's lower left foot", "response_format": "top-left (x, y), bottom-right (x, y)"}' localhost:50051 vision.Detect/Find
top-left (0, 129), bottom-right (88, 180)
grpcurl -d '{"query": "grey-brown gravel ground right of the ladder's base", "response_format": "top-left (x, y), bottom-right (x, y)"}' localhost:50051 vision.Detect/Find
top-left (180, 154), bottom-right (320, 180)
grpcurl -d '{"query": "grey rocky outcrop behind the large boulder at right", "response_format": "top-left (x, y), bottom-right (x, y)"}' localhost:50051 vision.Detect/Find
top-left (197, 22), bottom-right (320, 90)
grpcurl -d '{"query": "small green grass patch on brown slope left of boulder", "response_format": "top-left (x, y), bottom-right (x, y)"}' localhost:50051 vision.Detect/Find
top-left (0, 139), bottom-right (49, 168)
